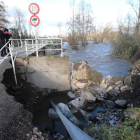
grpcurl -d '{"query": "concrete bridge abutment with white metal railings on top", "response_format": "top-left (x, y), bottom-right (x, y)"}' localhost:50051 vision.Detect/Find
top-left (0, 38), bottom-right (70, 91)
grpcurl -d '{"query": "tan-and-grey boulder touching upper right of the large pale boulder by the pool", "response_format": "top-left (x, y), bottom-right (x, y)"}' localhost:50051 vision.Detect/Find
top-left (81, 92), bottom-right (96, 102)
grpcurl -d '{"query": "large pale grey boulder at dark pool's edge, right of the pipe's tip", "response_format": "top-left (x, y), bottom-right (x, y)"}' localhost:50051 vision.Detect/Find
top-left (68, 97), bottom-right (87, 109)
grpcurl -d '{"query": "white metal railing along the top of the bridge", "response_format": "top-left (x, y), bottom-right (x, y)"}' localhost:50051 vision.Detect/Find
top-left (10, 38), bottom-right (63, 57)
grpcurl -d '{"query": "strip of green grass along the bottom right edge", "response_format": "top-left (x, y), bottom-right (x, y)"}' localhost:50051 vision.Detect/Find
top-left (85, 124), bottom-right (140, 140)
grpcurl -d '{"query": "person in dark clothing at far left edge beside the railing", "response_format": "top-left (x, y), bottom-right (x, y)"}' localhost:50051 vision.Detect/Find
top-left (0, 26), bottom-right (6, 57)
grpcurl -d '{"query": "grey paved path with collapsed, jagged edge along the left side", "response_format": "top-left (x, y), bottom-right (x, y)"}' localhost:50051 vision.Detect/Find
top-left (0, 58), bottom-right (22, 139)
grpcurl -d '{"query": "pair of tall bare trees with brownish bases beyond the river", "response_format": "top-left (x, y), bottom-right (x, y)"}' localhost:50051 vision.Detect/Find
top-left (67, 0), bottom-right (94, 49)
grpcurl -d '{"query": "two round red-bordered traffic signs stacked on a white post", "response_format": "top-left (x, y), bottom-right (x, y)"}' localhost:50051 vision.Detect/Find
top-left (29, 3), bottom-right (40, 57)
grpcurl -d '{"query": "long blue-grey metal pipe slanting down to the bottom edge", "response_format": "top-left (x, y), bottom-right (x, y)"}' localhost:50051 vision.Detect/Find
top-left (51, 101), bottom-right (93, 140)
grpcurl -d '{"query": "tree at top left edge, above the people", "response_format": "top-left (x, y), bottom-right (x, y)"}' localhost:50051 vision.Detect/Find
top-left (0, 1), bottom-right (9, 26)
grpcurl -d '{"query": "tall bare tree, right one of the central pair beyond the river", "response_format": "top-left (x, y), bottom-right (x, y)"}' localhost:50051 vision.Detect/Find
top-left (75, 0), bottom-right (94, 47)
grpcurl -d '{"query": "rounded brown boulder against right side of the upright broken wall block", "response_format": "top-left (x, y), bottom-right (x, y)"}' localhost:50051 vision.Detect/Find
top-left (89, 70), bottom-right (103, 85)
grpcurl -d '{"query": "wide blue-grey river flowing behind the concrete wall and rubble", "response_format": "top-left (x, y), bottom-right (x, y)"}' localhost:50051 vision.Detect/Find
top-left (63, 41), bottom-right (132, 77)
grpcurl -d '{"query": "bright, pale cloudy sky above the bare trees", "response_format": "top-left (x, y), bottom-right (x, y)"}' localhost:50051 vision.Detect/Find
top-left (4, 0), bottom-right (138, 35)
